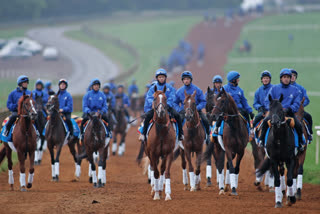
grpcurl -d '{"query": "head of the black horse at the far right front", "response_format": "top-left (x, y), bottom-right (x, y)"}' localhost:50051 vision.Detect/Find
top-left (268, 94), bottom-right (285, 128)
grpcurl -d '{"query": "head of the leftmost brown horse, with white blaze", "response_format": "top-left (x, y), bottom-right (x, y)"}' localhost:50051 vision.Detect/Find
top-left (18, 93), bottom-right (37, 120)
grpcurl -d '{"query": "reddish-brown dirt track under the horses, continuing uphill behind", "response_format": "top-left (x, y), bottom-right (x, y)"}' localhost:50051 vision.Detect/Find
top-left (0, 17), bottom-right (320, 213)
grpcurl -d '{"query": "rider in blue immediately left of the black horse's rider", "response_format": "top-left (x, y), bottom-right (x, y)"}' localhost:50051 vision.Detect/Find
top-left (252, 70), bottom-right (273, 127)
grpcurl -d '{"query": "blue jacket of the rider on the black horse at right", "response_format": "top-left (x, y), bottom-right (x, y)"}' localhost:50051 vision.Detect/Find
top-left (265, 83), bottom-right (301, 113)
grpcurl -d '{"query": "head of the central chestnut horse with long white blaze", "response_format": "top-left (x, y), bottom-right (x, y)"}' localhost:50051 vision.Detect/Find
top-left (152, 86), bottom-right (167, 118)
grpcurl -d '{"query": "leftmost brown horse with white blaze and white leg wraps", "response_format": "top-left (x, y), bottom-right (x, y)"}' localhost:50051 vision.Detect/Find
top-left (4, 94), bottom-right (37, 192)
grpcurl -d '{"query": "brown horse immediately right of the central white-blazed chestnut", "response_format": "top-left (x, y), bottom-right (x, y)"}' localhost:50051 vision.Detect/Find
top-left (176, 91), bottom-right (206, 192)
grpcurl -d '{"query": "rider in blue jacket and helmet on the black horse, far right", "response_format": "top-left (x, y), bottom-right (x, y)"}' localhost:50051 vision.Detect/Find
top-left (259, 68), bottom-right (303, 150)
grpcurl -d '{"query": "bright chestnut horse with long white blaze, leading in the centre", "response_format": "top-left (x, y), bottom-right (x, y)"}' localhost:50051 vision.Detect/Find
top-left (145, 86), bottom-right (176, 201)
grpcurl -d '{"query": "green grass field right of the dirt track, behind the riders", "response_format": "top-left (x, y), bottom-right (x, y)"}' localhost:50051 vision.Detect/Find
top-left (225, 13), bottom-right (320, 184)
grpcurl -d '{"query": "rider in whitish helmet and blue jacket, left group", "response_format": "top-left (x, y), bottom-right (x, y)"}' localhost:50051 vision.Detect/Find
top-left (58, 79), bottom-right (73, 139)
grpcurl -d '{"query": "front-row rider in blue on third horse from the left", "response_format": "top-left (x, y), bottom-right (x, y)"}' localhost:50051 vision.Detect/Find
top-left (80, 79), bottom-right (108, 139)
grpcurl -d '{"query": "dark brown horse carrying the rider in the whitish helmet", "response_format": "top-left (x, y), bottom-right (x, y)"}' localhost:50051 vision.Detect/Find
top-left (45, 92), bottom-right (81, 182)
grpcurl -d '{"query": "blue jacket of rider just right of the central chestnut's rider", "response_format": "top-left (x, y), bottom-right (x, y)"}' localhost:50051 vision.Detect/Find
top-left (174, 83), bottom-right (207, 112)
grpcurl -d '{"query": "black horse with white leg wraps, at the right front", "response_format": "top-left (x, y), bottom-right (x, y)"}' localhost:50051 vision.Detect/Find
top-left (259, 94), bottom-right (296, 208)
